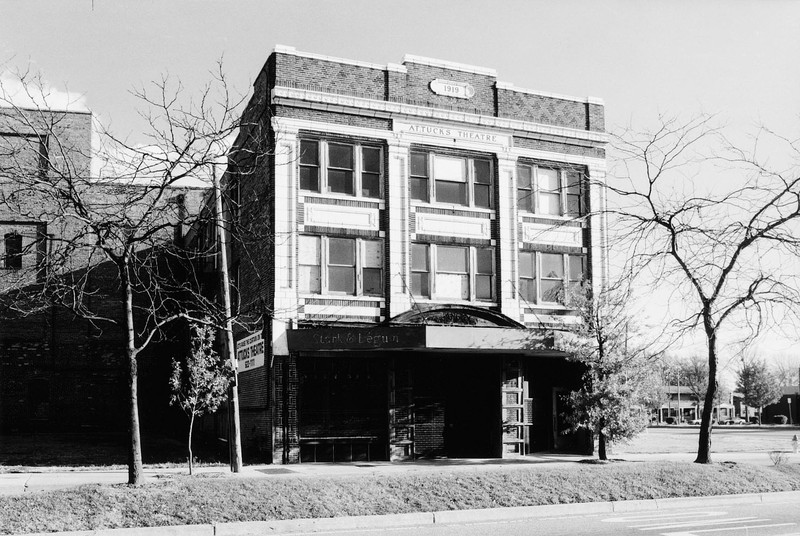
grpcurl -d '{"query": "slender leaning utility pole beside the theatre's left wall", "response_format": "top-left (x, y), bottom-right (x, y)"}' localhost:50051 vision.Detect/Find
top-left (211, 166), bottom-right (242, 473)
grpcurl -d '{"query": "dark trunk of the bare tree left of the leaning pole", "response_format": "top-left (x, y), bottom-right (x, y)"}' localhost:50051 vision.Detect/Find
top-left (120, 265), bottom-right (142, 485)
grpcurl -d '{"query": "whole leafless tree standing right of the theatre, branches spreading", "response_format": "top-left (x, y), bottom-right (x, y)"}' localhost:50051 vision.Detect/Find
top-left (609, 117), bottom-right (800, 463)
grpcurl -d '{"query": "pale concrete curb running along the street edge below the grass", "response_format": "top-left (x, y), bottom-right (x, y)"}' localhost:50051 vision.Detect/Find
top-left (12, 491), bottom-right (800, 536)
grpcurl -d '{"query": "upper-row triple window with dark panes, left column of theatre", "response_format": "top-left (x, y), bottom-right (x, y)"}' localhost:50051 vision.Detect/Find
top-left (300, 140), bottom-right (383, 198)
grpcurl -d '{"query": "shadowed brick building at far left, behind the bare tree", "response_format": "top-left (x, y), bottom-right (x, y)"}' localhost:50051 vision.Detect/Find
top-left (0, 104), bottom-right (202, 433)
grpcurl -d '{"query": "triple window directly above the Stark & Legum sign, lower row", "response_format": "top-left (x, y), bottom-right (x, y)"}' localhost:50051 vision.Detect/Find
top-left (298, 235), bottom-right (383, 296)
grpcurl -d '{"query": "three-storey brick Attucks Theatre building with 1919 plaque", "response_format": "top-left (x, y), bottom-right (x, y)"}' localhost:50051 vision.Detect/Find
top-left (216, 46), bottom-right (607, 463)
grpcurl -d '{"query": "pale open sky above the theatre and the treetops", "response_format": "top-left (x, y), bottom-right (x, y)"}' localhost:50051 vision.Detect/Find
top-left (0, 0), bottom-right (800, 368)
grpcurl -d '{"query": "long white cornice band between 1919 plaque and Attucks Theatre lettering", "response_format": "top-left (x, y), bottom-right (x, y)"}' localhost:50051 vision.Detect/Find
top-left (272, 86), bottom-right (609, 144)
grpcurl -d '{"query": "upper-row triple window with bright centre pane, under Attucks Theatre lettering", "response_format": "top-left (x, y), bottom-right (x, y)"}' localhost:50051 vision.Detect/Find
top-left (409, 152), bottom-right (493, 208)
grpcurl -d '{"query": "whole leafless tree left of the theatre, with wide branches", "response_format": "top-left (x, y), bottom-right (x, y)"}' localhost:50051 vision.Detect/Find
top-left (0, 65), bottom-right (256, 484)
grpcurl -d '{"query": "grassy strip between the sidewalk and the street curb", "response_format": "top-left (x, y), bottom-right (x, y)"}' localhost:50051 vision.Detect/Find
top-left (0, 462), bottom-right (800, 534)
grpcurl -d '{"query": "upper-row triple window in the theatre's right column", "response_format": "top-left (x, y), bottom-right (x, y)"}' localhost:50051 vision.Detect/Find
top-left (517, 164), bottom-right (585, 217)
